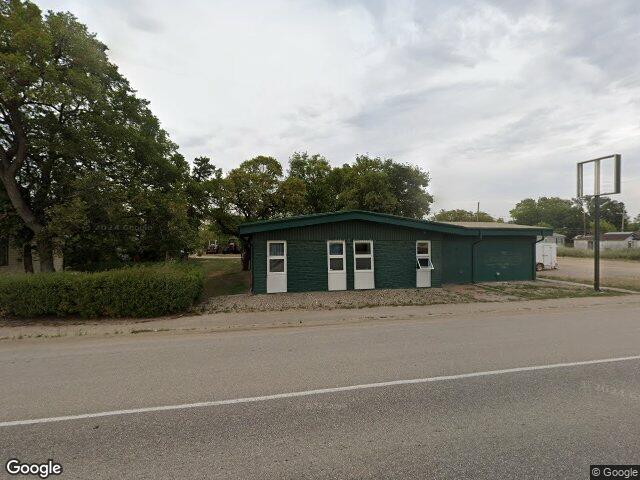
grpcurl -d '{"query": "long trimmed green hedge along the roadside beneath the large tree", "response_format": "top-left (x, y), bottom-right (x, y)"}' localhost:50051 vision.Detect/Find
top-left (0, 262), bottom-right (204, 317)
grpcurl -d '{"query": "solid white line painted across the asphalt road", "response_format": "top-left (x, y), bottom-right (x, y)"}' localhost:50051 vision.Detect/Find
top-left (0, 355), bottom-right (640, 427)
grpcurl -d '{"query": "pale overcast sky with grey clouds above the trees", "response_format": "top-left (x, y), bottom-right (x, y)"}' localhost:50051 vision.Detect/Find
top-left (36, 0), bottom-right (640, 216)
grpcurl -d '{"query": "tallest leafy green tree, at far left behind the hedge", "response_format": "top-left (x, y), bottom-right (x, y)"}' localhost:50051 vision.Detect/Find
top-left (0, 0), bottom-right (192, 271)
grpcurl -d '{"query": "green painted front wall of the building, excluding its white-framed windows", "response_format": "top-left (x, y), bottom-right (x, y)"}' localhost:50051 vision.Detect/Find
top-left (252, 221), bottom-right (535, 293)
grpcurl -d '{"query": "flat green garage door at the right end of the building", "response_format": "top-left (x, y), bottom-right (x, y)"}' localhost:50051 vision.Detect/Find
top-left (475, 237), bottom-right (535, 282)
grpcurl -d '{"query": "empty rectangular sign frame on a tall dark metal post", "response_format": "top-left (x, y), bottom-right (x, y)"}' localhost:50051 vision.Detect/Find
top-left (578, 154), bottom-right (622, 291)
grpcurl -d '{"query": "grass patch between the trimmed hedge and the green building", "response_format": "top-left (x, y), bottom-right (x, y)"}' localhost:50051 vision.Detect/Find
top-left (189, 257), bottom-right (251, 302)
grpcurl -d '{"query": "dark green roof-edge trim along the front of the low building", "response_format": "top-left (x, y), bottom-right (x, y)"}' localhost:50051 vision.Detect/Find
top-left (240, 210), bottom-right (553, 236)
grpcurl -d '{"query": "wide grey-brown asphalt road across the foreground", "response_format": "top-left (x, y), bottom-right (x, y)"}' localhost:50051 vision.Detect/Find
top-left (0, 296), bottom-right (640, 479)
